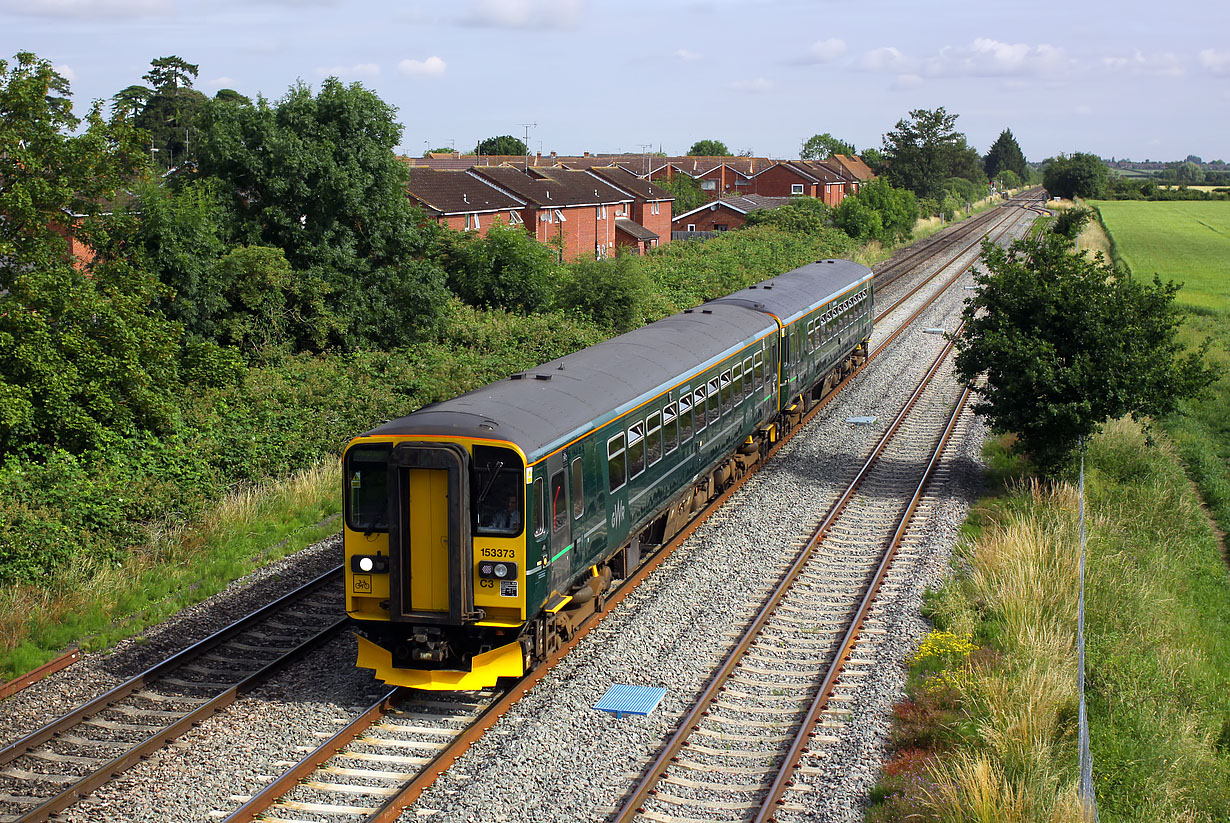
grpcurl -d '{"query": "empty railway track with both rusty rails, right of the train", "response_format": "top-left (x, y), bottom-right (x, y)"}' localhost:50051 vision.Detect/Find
top-left (613, 327), bottom-right (967, 823)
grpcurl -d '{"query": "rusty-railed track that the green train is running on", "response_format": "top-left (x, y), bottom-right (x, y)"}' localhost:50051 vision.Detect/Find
top-left (215, 199), bottom-right (1038, 823)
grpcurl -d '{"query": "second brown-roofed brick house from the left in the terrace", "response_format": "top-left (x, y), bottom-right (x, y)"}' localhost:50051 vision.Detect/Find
top-left (466, 166), bottom-right (633, 261)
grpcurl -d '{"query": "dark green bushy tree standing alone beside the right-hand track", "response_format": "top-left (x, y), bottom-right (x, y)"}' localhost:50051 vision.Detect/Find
top-left (957, 233), bottom-right (1214, 474)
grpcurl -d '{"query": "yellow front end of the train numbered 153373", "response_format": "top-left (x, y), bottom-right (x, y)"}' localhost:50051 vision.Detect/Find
top-left (343, 437), bottom-right (528, 690)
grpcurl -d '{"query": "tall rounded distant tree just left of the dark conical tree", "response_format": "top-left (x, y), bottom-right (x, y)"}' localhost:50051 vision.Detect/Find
top-left (884, 106), bottom-right (966, 201)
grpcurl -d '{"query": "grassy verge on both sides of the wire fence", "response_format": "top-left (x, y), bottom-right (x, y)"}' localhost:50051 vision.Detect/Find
top-left (867, 422), bottom-right (1230, 823)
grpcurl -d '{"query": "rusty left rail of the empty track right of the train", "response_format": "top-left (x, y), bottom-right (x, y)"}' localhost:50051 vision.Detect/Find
top-left (611, 312), bottom-right (953, 823)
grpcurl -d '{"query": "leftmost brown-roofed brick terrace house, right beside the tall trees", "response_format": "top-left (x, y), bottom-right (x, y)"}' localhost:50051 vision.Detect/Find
top-left (406, 166), bottom-right (525, 236)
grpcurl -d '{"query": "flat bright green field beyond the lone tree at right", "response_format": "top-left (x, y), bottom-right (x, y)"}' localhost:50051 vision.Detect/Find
top-left (1095, 201), bottom-right (1230, 312)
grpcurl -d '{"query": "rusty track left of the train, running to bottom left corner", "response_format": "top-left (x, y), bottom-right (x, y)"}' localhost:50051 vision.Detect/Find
top-left (0, 566), bottom-right (344, 823)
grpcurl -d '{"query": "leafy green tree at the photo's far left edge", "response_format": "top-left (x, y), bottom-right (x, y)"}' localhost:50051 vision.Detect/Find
top-left (0, 53), bottom-right (189, 454)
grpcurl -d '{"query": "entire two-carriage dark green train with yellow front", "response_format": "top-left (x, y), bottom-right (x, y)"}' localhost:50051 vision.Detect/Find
top-left (343, 261), bottom-right (872, 689)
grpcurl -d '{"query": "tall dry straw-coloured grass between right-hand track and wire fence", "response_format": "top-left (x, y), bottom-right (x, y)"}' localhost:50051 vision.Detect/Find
top-left (925, 481), bottom-right (1082, 823)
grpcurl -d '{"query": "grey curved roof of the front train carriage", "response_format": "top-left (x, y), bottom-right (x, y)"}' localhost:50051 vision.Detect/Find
top-left (367, 305), bottom-right (777, 463)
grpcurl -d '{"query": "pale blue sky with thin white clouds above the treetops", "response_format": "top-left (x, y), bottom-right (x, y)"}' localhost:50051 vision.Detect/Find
top-left (0, 0), bottom-right (1230, 160)
